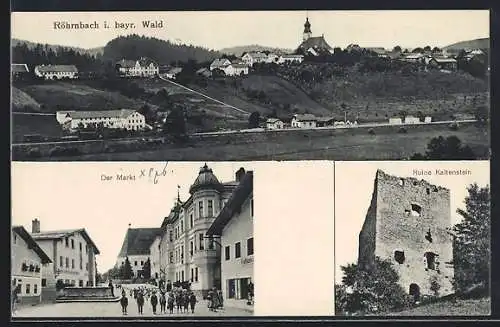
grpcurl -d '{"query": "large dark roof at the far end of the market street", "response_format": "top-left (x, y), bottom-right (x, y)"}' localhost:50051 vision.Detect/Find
top-left (118, 228), bottom-right (161, 257)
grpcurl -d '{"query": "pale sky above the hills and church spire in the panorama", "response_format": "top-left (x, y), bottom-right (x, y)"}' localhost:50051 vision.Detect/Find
top-left (11, 10), bottom-right (490, 50)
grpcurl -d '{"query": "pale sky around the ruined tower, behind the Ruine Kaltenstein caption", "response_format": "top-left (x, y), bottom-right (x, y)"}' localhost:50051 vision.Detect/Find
top-left (335, 161), bottom-right (490, 282)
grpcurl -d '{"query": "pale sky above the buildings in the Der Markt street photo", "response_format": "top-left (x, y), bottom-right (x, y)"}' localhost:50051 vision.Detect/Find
top-left (12, 162), bottom-right (254, 273)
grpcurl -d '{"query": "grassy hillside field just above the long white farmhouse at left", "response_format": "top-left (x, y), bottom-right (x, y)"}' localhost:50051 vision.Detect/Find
top-left (17, 82), bottom-right (154, 112)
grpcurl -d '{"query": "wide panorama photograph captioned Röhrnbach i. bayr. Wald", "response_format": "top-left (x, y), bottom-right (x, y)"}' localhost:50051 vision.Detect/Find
top-left (11, 10), bottom-right (491, 161)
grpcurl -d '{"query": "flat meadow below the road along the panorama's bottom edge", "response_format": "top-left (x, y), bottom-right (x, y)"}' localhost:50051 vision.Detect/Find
top-left (34, 125), bottom-right (490, 161)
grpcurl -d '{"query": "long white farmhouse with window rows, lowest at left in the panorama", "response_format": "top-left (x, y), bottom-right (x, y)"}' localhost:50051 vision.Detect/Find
top-left (56, 109), bottom-right (146, 131)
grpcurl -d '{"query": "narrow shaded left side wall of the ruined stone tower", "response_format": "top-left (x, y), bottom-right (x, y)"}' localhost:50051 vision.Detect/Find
top-left (358, 180), bottom-right (377, 269)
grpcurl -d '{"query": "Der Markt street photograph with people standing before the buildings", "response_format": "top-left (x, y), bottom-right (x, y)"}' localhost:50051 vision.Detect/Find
top-left (10, 162), bottom-right (254, 318)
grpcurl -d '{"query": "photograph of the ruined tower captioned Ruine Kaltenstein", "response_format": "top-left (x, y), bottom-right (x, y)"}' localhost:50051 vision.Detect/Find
top-left (334, 161), bottom-right (491, 316)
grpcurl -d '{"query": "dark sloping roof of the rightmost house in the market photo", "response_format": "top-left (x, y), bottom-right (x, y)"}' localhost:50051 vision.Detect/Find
top-left (207, 171), bottom-right (253, 235)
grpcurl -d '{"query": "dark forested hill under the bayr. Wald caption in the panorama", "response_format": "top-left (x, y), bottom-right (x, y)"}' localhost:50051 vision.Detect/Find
top-left (103, 34), bottom-right (220, 64)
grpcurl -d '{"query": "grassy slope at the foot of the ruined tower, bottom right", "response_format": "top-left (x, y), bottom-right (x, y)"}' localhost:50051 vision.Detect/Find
top-left (387, 298), bottom-right (491, 316)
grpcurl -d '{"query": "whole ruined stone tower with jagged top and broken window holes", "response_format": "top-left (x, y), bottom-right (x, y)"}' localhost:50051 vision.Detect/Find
top-left (358, 170), bottom-right (454, 298)
